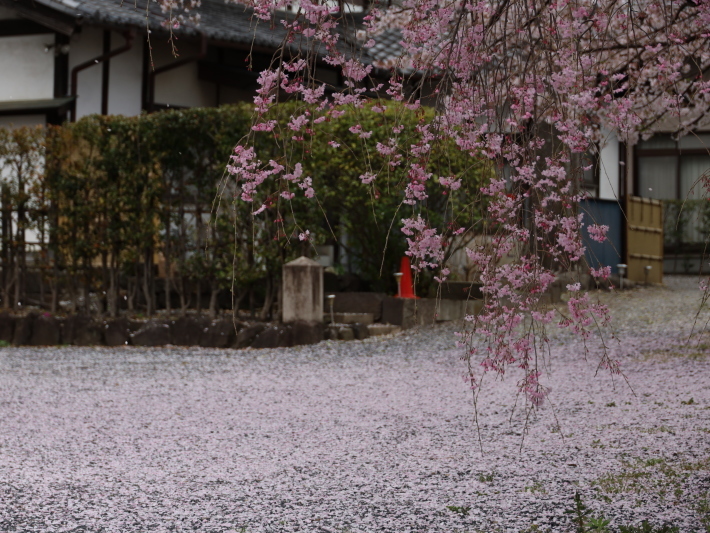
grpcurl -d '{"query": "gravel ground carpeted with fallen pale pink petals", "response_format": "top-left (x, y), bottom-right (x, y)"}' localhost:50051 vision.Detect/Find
top-left (0, 278), bottom-right (710, 533)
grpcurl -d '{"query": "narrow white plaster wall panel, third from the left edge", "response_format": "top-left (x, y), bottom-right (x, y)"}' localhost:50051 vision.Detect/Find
top-left (108, 32), bottom-right (143, 116)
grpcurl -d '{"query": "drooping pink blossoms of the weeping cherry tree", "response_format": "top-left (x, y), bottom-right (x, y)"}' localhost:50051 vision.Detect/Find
top-left (217, 0), bottom-right (710, 404)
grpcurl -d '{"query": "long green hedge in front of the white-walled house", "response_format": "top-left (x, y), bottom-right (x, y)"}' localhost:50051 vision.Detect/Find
top-left (0, 103), bottom-right (488, 316)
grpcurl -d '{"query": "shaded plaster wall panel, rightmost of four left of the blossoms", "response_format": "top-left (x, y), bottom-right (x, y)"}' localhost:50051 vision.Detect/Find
top-left (157, 41), bottom-right (217, 107)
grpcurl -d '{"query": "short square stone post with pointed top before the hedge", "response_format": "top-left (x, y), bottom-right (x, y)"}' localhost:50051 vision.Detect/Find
top-left (281, 256), bottom-right (323, 323)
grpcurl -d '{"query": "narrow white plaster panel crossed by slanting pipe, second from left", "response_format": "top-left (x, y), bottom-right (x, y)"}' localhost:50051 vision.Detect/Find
top-left (69, 27), bottom-right (103, 120)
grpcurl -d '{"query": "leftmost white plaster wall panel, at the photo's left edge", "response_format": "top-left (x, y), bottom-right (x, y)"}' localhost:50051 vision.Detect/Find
top-left (0, 33), bottom-right (54, 101)
